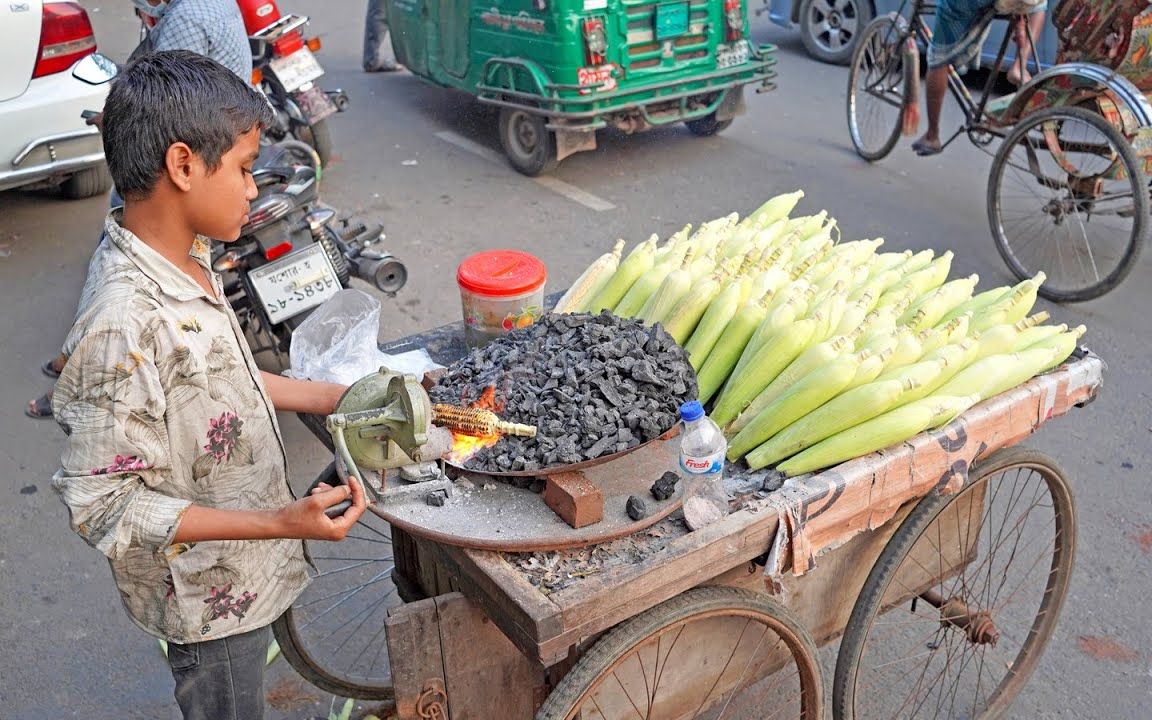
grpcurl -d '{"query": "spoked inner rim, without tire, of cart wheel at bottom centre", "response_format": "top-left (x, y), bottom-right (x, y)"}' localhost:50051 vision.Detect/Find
top-left (552, 608), bottom-right (814, 720)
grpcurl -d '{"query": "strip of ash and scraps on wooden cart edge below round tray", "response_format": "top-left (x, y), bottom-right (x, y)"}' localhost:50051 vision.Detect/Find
top-left (503, 517), bottom-right (688, 596)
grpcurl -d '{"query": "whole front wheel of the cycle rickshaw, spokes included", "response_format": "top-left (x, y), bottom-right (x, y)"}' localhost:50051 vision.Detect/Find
top-left (848, 13), bottom-right (911, 162)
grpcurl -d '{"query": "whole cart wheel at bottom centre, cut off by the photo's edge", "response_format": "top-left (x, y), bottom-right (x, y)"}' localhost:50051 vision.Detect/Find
top-left (536, 588), bottom-right (824, 720)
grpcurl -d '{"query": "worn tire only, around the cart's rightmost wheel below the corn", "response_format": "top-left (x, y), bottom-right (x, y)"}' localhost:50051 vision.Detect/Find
top-left (832, 447), bottom-right (1076, 720)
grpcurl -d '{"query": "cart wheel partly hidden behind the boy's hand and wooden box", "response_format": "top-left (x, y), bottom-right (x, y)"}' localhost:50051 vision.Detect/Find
top-left (272, 464), bottom-right (402, 700)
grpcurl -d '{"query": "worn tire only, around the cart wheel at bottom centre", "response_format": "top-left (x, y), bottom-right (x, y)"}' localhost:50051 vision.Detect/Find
top-left (536, 588), bottom-right (824, 720)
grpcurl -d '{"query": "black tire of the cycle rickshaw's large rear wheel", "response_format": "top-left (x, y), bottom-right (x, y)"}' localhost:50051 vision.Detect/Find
top-left (987, 107), bottom-right (1150, 303)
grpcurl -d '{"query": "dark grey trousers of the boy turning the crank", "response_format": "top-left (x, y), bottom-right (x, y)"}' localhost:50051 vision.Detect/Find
top-left (168, 627), bottom-right (272, 720)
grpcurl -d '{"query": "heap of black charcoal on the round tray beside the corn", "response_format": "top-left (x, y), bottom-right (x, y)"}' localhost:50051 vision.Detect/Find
top-left (430, 312), bottom-right (696, 472)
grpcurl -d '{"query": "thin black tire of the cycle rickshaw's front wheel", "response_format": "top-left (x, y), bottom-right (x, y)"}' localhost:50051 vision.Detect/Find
top-left (847, 13), bottom-right (910, 162)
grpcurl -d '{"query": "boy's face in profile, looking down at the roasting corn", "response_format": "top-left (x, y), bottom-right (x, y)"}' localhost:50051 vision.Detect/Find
top-left (188, 127), bottom-right (260, 242)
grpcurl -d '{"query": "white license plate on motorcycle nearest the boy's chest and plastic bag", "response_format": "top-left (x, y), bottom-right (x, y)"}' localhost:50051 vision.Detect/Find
top-left (248, 245), bottom-right (340, 325)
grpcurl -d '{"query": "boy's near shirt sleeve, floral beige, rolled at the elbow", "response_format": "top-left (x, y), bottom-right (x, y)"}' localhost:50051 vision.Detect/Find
top-left (53, 328), bottom-right (191, 559)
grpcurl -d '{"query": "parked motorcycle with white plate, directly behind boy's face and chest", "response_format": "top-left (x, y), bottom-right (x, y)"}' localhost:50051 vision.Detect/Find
top-left (212, 141), bottom-right (408, 362)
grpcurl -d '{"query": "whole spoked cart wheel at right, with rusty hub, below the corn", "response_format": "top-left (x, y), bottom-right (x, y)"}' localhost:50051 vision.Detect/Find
top-left (832, 448), bottom-right (1076, 720)
